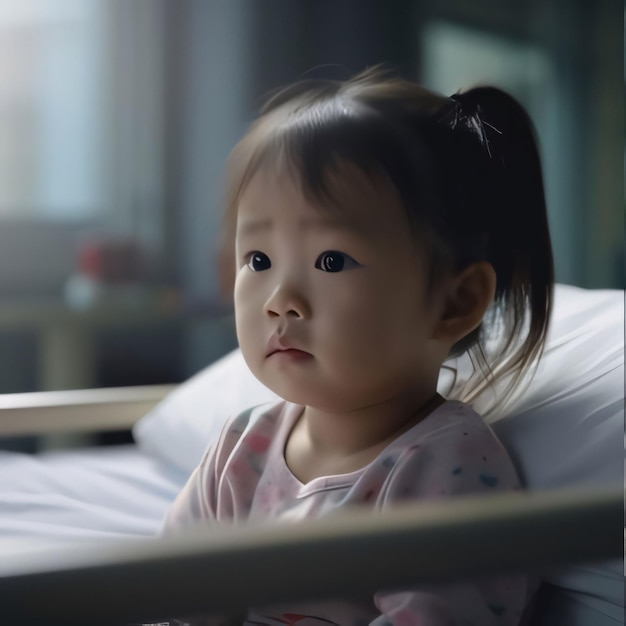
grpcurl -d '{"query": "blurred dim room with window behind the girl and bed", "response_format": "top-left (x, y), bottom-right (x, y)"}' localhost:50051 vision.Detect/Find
top-left (0, 0), bottom-right (624, 393)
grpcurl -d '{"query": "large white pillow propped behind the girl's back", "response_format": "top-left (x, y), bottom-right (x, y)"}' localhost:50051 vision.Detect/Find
top-left (133, 285), bottom-right (624, 626)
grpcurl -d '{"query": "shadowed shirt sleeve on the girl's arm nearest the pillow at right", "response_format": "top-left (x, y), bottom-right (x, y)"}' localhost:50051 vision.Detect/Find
top-left (371, 412), bottom-right (529, 626)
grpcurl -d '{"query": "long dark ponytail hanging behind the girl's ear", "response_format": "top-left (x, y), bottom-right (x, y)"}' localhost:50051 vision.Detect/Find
top-left (444, 87), bottom-right (554, 400)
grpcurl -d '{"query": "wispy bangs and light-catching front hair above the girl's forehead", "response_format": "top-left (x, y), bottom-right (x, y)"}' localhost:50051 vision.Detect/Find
top-left (228, 92), bottom-right (434, 223)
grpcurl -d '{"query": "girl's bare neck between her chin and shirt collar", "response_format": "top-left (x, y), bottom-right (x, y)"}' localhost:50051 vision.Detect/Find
top-left (285, 392), bottom-right (445, 483)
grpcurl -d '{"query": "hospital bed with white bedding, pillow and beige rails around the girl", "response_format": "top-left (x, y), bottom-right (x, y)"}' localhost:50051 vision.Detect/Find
top-left (0, 285), bottom-right (624, 626)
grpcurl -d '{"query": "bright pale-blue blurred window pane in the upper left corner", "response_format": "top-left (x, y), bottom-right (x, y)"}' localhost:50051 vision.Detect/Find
top-left (0, 0), bottom-right (107, 218)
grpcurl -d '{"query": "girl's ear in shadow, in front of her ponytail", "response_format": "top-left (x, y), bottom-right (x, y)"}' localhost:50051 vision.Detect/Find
top-left (435, 261), bottom-right (496, 345)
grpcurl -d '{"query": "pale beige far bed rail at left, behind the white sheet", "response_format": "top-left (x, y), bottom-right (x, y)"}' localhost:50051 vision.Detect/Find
top-left (0, 385), bottom-right (175, 437)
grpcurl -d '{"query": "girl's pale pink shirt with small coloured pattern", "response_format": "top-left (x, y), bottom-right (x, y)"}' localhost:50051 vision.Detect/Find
top-left (166, 401), bottom-right (529, 626)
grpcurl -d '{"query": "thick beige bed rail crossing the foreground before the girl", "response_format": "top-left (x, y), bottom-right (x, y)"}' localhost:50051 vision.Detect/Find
top-left (0, 489), bottom-right (623, 626)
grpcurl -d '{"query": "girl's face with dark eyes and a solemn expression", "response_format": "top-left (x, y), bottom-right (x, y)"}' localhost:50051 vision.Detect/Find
top-left (235, 163), bottom-right (441, 411)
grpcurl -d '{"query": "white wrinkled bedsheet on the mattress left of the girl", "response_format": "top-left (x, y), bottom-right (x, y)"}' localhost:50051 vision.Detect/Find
top-left (0, 444), bottom-right (187, 557)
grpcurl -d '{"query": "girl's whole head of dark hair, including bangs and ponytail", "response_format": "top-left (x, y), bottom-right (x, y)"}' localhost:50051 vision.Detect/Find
top-left (223, 68), bottom-right (554, 404)
